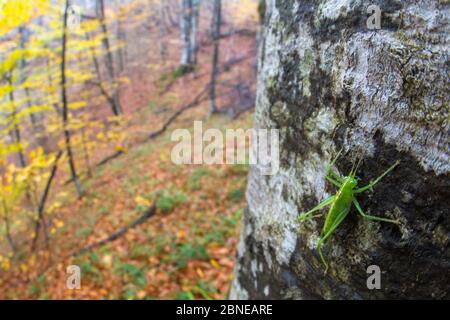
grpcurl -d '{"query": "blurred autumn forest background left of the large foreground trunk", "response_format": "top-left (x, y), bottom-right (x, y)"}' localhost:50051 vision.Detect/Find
top-left (0, 0), bottom-right (264, 299)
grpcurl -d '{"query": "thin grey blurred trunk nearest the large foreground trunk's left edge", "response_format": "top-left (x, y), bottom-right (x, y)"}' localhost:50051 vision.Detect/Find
top-left (209, 0), bottom-right (222, 114)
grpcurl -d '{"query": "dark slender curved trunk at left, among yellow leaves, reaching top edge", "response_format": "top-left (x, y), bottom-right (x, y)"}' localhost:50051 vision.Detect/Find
top-left (61, 0), bottom-right (83, 198)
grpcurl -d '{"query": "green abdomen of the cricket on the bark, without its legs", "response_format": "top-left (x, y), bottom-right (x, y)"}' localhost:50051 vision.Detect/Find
top-left (322, 183), bottom-right (353, 234)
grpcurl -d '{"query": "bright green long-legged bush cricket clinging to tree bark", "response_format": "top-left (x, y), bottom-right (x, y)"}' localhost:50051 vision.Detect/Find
top-left (299, 150), bottom-right (400, 273)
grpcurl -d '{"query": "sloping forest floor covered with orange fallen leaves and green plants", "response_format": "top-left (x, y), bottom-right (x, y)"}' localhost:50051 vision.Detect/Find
top-left (0, 8), bottom-right (256, 299)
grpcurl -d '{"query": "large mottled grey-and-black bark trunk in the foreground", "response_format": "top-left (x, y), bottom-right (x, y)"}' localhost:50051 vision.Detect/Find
top-left (230, 0), bottom-right (450, 299)
